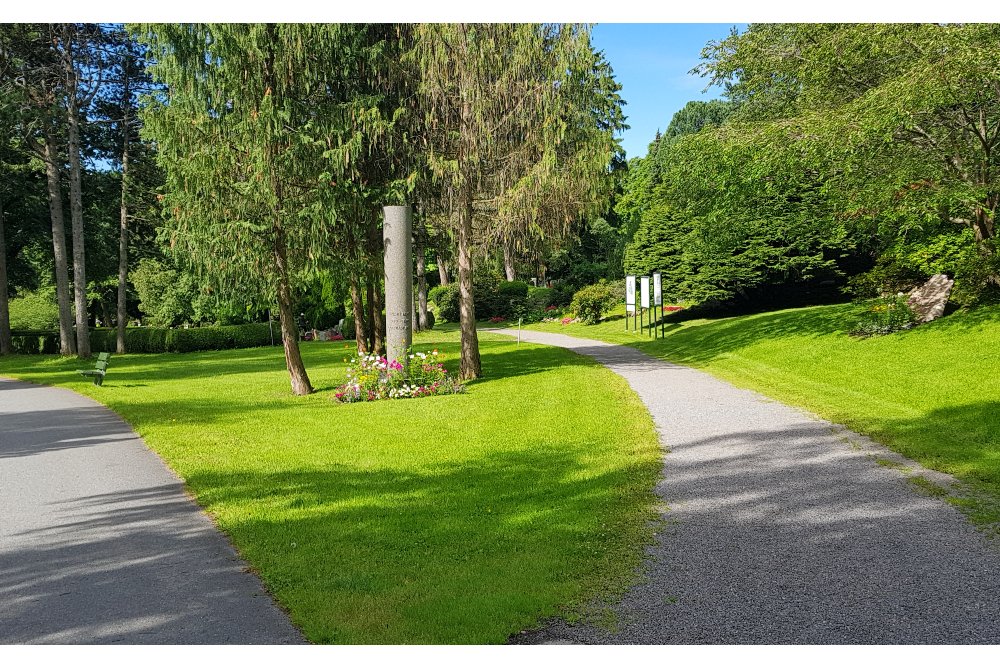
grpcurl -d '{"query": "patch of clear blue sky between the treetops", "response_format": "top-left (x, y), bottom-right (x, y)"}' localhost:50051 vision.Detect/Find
top-left (593, 23), bottom-right (746, 158)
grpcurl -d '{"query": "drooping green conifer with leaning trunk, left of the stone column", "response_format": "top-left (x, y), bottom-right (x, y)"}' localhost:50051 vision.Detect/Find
top-left (140, 24), bottom-right (408, 394)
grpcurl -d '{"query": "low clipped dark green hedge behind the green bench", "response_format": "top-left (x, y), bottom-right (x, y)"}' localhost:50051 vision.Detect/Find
top-left (11, 323), bottom-right (281, 354)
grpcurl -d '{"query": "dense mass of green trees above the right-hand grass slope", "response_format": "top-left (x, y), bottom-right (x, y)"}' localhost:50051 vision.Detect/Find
top-left (618, 24), bottom-right (1000, 304)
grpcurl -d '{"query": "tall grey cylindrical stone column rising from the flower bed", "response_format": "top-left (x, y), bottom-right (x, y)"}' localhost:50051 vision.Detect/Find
top-left (382, 206), bottom-right (413, 369)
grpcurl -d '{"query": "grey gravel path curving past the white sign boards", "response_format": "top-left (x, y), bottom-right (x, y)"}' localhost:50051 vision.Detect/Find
top-left (497, 331), bottom-right (1000, 644)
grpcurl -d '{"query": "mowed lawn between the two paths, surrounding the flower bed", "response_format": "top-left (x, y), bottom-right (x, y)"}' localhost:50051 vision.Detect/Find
top-left (0, 332), bottom-right (661, 643)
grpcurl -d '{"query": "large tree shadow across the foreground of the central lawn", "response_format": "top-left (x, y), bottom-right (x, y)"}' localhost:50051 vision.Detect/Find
top-left (182, 442), bottom-right (658, 643)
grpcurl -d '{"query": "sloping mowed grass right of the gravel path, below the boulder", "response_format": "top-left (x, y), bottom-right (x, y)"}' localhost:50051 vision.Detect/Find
top-left (531, 304), bottom-right (1000, 523)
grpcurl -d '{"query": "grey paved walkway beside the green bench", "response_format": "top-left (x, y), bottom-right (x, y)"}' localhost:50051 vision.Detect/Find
top-left (0, 378), bottom-right (303, 644)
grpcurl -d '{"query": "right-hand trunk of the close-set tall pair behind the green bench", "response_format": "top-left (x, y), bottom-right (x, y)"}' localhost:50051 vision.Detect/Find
top-left (62, 24), bottom-right (90, 359)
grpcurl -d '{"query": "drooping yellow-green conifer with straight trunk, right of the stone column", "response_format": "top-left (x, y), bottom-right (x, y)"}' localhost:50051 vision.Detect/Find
top-left (412, 23), bottom-right (613, 379)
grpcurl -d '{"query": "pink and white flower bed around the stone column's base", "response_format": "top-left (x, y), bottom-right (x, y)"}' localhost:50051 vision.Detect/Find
top-left (334, 350), bottom-right (465, 403)
